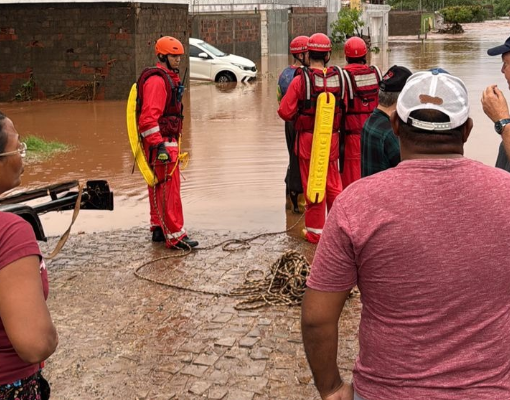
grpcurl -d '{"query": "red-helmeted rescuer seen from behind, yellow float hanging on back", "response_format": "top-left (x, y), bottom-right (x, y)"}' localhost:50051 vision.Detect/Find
top-left (278, 33), bottom-right (345, 243)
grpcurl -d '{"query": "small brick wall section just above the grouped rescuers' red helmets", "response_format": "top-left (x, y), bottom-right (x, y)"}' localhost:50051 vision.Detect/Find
top-left (289, 7), bottom-right (328, 44)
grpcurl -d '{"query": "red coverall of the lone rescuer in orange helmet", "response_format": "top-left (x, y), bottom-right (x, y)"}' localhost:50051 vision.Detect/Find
top-left (138, 63), bottom-right (186, 247)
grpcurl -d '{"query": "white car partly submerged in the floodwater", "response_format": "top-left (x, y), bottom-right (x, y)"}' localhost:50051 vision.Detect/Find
top-left (189, 38), bottom-right (257, 82)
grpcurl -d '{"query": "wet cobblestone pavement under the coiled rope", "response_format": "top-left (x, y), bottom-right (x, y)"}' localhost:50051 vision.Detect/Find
top-left (41, 228), bottom-right (360, 400)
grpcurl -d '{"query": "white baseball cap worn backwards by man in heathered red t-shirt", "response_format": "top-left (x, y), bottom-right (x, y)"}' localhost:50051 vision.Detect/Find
top-left (397, 68), bottom-right (469, 131)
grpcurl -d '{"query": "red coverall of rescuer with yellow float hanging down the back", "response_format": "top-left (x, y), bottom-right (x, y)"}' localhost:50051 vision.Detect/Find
top-left (278, 68), bottom-right (342, 243)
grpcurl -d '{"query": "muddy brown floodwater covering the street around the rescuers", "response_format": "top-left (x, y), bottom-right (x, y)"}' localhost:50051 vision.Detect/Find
top-left (0, 20), bottom-right (510, 236)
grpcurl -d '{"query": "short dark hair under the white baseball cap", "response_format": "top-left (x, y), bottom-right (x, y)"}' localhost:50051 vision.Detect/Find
top-left (399, 110), bottom-right (465, 153)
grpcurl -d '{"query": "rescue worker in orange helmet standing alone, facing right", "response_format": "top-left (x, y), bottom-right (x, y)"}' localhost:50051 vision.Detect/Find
top-left (137, 36), bottom-right (198, 249)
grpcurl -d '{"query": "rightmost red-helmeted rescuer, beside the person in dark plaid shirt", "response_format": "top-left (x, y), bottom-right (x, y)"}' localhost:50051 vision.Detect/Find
top-left (340, 37), bottom-right (381, 189)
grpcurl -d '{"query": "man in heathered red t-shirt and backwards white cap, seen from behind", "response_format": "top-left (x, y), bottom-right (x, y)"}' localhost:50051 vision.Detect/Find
top-left (302, 69), bottom-right (510, 400)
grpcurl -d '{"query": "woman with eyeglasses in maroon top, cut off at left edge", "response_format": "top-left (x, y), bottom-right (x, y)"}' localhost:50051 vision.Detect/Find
top-left (0, 112), bottom-right (58, 400)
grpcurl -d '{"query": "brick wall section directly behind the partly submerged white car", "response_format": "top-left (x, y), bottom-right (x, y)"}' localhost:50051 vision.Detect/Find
top-left (191, 12), bottom-right (261, 60)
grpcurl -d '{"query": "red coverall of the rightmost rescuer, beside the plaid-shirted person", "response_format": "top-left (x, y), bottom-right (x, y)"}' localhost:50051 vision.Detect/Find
top-left (341, 64), bottom-right (378, 189)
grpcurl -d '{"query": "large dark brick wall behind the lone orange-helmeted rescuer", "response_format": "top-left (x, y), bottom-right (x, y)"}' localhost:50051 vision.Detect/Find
top-left (0, 3), bottom-right (188, 101)
